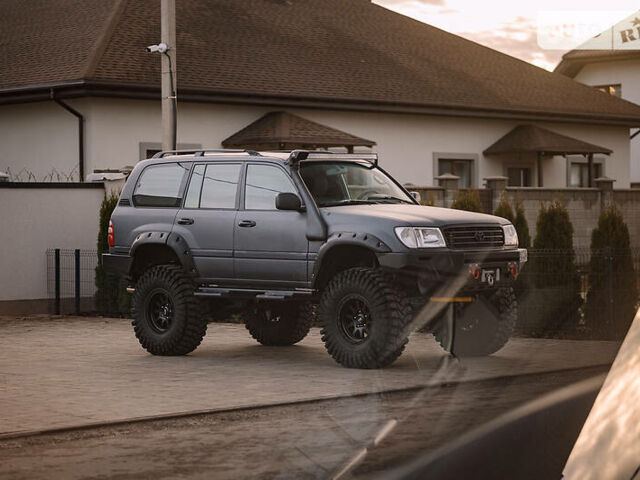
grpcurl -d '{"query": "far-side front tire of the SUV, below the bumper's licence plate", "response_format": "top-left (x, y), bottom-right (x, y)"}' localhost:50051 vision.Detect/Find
top-left (433, 287), bottom-right (518, 357)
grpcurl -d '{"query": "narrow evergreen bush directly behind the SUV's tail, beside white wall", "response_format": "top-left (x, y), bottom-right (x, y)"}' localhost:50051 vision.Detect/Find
top-left (94, 192), bottom-right (130, 315)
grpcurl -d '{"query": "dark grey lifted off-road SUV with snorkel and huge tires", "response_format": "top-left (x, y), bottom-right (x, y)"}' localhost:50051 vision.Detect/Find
top-left (103, 150), bottom-right (527, 368)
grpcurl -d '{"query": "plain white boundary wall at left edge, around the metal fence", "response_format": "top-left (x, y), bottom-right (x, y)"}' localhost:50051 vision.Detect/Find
top-left (0, 188), bottom-right (104, 302)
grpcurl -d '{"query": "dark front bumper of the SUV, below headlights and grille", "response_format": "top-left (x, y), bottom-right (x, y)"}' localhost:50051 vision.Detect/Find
top-left (378, 248), bottom-right (527, 287)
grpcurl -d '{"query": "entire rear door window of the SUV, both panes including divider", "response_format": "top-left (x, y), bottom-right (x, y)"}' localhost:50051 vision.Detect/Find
top-left (184, 163), bottom-right (240, 209)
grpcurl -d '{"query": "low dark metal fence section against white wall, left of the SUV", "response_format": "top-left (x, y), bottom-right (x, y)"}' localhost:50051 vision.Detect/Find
top-left (47, 248), bottom-right (98, 315)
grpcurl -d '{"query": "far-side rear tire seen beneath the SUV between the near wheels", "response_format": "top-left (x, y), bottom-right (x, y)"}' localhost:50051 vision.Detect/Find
top-left (242, 302), bottom-right (313, 346)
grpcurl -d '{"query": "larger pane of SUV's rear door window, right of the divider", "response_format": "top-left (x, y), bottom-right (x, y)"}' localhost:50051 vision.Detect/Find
top-left (200, 164), bottom-right (240, 208)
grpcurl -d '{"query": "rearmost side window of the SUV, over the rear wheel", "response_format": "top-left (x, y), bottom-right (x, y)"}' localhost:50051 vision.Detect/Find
top-left (133, 163), bottom-right (189, 207)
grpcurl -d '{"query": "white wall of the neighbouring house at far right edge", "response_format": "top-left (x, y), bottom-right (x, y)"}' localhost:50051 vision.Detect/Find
top-left (575, 60), bottom-right (640, 182)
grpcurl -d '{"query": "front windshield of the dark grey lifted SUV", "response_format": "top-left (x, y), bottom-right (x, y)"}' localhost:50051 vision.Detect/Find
top-left (300, 162), bottom-right (415, 207)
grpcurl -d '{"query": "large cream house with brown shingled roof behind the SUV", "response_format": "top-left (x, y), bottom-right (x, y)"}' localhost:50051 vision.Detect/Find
top-left (0, 0), bottom-right (640, 188)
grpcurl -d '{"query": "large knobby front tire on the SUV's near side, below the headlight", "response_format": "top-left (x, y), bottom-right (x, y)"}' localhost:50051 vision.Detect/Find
top-left (318, 268), bottom-right (411, 368)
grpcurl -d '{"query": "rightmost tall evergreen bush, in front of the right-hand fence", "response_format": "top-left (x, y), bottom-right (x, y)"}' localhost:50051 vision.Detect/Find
top-left (585, 205), bottom-right (638, 339)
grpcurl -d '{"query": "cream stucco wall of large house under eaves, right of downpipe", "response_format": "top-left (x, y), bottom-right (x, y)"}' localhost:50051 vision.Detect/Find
top-left (82, 99), bottom-right (629, 188)
